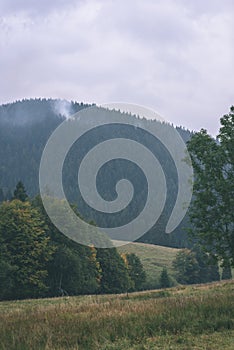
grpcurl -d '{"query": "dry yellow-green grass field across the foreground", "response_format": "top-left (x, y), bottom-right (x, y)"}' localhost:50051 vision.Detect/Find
top-left (0, 281), bottom-right (234, 350)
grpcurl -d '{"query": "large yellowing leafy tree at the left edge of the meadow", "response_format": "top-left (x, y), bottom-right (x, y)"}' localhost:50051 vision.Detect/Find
top-left (0, 200), bottom-right (53, 298)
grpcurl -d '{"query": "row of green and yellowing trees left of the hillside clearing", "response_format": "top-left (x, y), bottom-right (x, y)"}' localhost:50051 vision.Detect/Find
top-left (0, 182), bottom-right (146, 300)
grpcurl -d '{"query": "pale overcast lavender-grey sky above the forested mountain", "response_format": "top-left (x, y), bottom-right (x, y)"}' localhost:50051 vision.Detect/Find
top-left (0, 0), bottom-right (234, 135)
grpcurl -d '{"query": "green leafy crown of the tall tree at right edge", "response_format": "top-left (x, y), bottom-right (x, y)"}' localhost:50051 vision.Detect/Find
top-left (188, 107), bottom-right (234, 265)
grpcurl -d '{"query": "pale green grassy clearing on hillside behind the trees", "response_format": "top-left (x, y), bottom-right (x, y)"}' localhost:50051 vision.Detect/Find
top-left (118, 243), bottom-right (179, 288)
